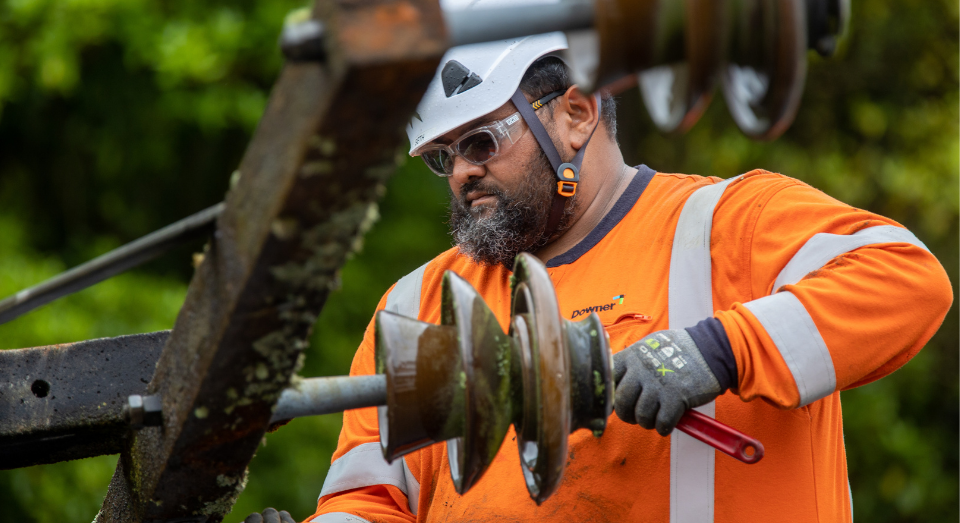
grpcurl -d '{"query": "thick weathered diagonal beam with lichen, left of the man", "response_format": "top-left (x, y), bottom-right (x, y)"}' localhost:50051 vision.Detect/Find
top-left (97, 0), bottom-right (446, 523)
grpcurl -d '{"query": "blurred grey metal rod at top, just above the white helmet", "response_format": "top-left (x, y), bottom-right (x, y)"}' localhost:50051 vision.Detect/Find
top-left (443, 0), bottom-right (594, 45)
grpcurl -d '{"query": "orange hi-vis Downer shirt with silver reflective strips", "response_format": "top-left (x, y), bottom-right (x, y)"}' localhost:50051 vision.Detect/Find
top-left (308, 166), bottom-right (953, 523)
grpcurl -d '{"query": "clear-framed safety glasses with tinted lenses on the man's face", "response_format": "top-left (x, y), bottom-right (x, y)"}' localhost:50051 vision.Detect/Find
top-left (420, 112), bottom-right (527, 177)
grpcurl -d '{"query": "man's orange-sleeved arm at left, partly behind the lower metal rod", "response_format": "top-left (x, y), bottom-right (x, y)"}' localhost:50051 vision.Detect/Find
top-left (306, 293), bottom-right (419, 523)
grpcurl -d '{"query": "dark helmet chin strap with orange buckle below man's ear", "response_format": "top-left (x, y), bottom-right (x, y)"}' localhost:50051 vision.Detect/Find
top-left (510, 88), bottom-right (600, 237)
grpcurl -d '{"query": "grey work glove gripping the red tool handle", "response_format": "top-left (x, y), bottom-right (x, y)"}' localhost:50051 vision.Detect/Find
top-left (613, 329), bottom-right (720, 436)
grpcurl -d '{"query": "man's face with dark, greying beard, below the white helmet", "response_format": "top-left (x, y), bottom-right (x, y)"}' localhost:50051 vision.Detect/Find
top-left (437, 102), bottom-right (568, 267)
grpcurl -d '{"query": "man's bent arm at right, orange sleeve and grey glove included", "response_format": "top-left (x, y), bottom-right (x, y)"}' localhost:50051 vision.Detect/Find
top-left (614, 172), bottom-right (953, 434)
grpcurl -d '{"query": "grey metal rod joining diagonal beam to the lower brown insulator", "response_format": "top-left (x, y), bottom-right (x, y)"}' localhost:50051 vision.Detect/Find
top-left (270, 374), bottom-right (387, 423)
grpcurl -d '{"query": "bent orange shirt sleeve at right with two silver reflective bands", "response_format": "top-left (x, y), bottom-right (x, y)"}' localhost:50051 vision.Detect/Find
top-left (712, 175), bottom-right (953, 408)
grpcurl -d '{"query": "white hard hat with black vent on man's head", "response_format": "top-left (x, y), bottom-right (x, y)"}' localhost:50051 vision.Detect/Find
top-left (407, 32), bottom-right (567, 156)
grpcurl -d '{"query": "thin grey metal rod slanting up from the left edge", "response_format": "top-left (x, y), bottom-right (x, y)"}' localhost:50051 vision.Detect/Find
top-left (0, 203), bottom-right (223, 324)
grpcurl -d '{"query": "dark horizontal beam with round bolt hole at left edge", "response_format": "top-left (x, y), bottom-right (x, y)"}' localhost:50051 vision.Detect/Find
top-left (0, 331), bottom-right (170, 469)
